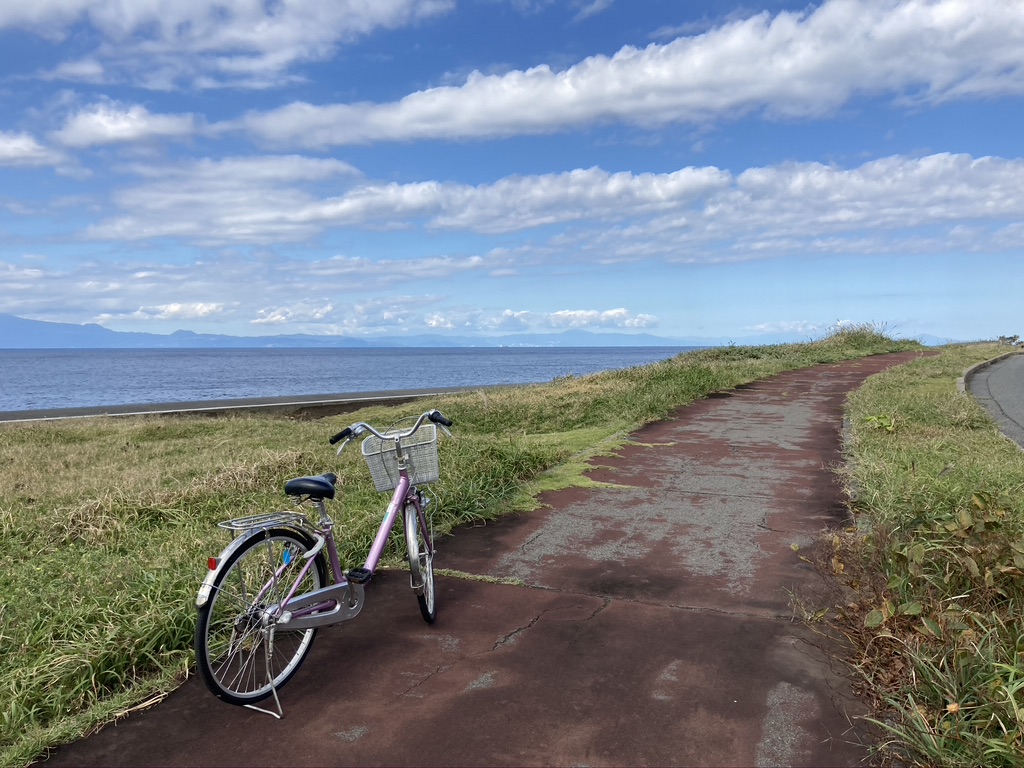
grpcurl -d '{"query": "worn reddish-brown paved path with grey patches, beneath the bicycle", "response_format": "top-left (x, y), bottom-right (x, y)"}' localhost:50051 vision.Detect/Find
top-left (41, 353), bottom-right (914, 766)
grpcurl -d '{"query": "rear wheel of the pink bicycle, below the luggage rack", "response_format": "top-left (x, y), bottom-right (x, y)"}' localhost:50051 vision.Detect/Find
top-left (196, 528), bottom-right (327, 705)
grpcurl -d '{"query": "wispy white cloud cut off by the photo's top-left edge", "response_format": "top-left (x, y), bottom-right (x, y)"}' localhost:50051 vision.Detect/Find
top-left (0, 0), bottom-right (455, 89)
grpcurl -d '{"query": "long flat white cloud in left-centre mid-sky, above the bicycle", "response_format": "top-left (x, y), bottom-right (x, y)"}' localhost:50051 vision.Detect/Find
top-left (83, 161), bottom-right (730, 243)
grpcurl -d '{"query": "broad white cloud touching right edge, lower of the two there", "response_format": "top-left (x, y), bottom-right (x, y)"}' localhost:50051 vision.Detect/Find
top-left (557, 154), bottom-right (1024, 264)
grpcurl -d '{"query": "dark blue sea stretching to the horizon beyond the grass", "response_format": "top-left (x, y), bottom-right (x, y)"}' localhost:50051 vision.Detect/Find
top-left (0, 346), bottom-right (696, 412)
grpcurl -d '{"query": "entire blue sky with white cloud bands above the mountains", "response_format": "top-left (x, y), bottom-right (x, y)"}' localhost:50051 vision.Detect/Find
top-left (0, 0), bottom-right (1024, 341)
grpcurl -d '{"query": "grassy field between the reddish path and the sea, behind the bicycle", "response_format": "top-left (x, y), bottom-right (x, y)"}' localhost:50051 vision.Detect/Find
top-left (0, 326), bottom-right (921, 766)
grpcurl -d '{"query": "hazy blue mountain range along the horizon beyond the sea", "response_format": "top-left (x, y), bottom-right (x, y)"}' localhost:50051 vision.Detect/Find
top-left (0, 314), bottom-right (946, 349)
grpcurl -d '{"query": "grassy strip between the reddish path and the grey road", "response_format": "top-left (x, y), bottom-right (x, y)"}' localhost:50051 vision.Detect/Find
top-left (831, 344), bottom-right (1024, 766)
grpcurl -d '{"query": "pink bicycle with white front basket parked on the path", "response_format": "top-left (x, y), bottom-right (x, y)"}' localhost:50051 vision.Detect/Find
top-left (195, 410), bottom-right (452, 719)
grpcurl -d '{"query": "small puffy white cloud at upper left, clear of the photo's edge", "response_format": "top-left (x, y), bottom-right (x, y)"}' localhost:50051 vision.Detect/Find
top-left (51, 101), bottom-right (196, 148)
